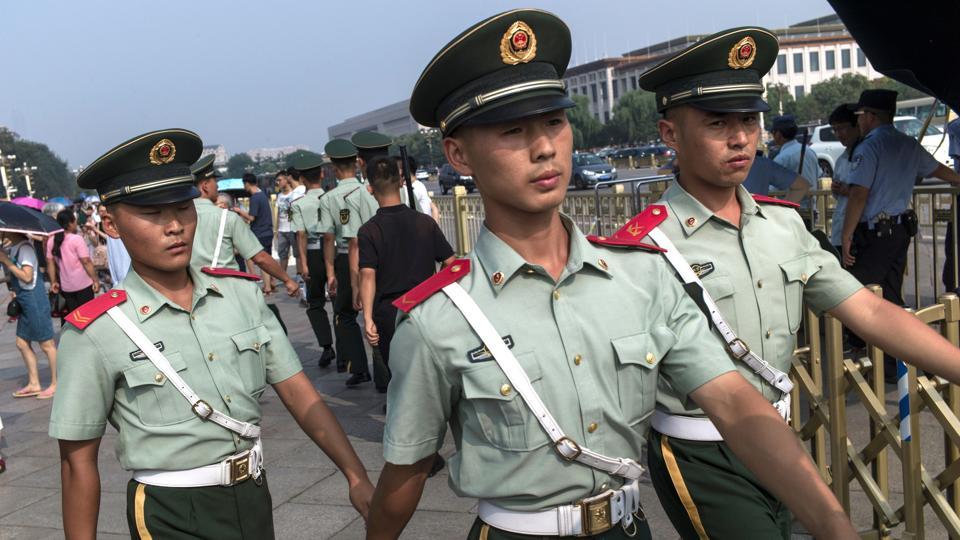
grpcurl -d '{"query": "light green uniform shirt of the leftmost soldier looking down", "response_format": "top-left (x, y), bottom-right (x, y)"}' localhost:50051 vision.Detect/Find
top-left (49, 268), bottom-right (302, 470)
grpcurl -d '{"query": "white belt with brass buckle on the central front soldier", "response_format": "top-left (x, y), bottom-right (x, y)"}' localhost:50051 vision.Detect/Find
top-left (478, 480), bottom-right (642, 536)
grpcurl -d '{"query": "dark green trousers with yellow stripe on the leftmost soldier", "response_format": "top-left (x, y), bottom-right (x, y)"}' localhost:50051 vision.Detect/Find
top-left (127, 473), bottom-right (273, 540)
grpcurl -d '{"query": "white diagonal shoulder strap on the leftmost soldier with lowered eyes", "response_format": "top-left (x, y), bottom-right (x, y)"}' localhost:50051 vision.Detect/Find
top-left (107, 306), bottom-right (260, 439)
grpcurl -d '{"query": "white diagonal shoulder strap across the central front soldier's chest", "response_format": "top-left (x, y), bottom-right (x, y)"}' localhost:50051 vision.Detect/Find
top-left (443, 283), bottom-right (643, 480)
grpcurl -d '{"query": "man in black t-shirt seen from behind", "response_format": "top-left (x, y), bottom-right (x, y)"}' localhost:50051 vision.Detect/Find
top-left (357, 157), bottom-right (453, 382)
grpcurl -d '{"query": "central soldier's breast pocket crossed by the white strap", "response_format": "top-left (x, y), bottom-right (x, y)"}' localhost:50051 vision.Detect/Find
top-left (462, 351), bottom-right (550, 452)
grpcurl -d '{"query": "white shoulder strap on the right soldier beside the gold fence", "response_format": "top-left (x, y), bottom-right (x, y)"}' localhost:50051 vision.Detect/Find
top-left (648, 227), bottom-right (793, 394)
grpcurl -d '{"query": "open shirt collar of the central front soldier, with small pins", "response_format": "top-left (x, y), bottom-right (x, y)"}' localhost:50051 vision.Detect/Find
top-left (473, 214), bottom-right (610, 294)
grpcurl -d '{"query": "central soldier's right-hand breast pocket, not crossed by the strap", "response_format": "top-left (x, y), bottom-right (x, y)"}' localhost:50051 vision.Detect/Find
top-left (610, 327), bottom-right (677, 426)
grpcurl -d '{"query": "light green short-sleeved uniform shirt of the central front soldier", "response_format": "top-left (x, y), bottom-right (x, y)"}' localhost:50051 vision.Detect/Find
top-left (383, 217), bottom-right (735, 510)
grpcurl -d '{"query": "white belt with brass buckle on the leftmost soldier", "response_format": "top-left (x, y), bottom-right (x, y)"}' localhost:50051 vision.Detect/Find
top-left (133, 439), bottom-right (263, 487)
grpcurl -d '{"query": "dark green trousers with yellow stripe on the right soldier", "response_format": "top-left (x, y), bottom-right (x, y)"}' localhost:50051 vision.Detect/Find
top-left (647, 429), bottom-right (792, 540)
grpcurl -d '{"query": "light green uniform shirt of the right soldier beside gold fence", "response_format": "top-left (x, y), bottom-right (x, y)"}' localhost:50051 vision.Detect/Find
top-left (657, 182), bottom-right (863, 415)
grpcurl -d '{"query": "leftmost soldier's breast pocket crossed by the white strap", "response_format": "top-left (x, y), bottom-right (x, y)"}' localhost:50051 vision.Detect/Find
top-left (123, 352), bottom-right (194, 426)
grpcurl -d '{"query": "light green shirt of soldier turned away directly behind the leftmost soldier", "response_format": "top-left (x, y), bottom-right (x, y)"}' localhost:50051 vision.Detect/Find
top-left (190, 197), bottom-right (263, 270)
